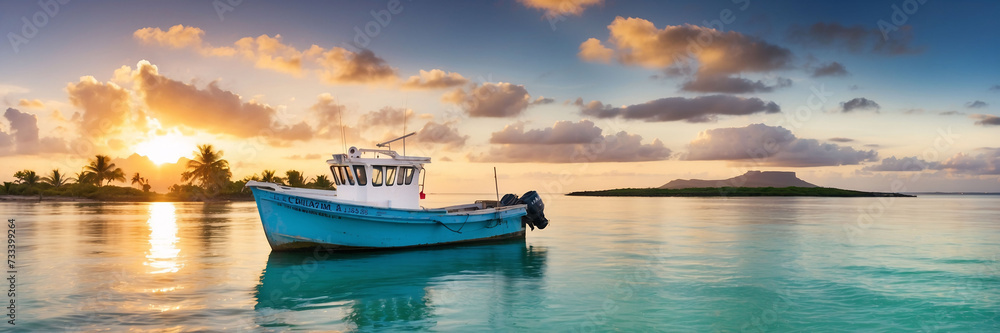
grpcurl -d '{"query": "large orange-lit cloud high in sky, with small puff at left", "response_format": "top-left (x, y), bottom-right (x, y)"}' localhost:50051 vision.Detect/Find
top-left (580, 16), bottom-right (792, 75)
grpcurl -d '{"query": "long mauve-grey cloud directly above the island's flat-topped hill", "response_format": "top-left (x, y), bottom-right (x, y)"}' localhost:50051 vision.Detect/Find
top-left (685, 124), bottom-right (878, 167)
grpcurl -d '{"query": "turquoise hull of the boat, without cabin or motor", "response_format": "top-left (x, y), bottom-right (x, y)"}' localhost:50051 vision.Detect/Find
top-left (251, 187), bottom-right (527, 251)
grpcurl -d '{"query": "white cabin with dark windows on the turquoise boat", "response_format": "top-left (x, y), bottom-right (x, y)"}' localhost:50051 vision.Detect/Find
top-left (326, 147), bottom-right (431, 209)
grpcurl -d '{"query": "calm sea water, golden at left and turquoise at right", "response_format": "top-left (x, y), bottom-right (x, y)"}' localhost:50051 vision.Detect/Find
top-left (0, 194), bottom-right (1000, 332)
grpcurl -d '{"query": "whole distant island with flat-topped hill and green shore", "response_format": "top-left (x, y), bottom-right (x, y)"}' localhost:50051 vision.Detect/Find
top-left (567, 171), bottom-right (915, 197)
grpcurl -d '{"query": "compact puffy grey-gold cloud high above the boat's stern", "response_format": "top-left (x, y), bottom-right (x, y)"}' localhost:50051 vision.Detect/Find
top-left (442, 82), bottom-right (531, 118)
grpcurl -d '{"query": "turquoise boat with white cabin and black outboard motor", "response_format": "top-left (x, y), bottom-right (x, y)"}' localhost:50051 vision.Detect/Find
top-left (246, 133), bottom-right (548, 251)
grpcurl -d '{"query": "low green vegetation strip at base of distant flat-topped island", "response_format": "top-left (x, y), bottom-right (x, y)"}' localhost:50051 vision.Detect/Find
top-left (567, 186), bottom-right (913, 197)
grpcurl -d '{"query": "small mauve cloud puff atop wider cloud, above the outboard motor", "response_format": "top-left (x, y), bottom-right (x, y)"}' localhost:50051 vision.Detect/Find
top-left (490, 120), bottom-right (602, 145)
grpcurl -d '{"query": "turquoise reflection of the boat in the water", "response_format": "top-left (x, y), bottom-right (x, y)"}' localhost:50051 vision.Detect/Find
top-left (255, 239), bottom-right (546, 330)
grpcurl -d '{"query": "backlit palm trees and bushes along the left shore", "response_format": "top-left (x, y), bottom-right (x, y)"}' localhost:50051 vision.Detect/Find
top-left (0, 144), bottom-right (334, 201)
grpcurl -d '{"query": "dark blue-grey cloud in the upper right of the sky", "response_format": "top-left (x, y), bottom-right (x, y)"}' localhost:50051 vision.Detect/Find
top-left (788, 22), bottom-right (921, 55)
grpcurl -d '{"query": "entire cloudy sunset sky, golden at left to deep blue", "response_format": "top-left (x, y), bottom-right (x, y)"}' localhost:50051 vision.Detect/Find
top-left (0, 0), bottom-right (1000, 193)
